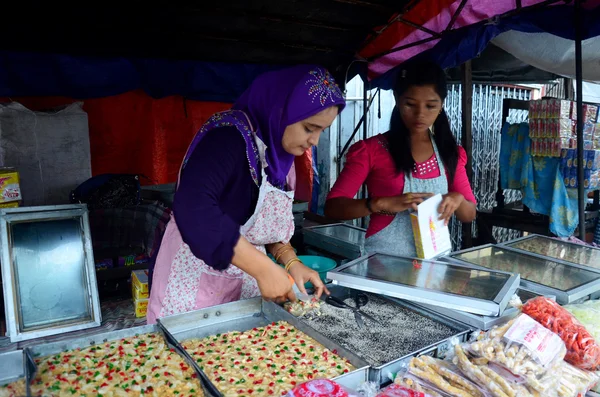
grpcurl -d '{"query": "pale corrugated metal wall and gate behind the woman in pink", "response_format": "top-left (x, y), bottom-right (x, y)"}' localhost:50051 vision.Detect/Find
top-left (318, 78), bottom-right (531, 248)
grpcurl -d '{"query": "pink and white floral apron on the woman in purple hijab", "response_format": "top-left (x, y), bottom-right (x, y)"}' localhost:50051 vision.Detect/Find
top-left (147, 111), bottom-right (294, 324)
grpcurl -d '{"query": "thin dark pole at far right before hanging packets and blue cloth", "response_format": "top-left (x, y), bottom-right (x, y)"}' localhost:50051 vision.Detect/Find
top-left (575, 0), bottom-right (587, 241)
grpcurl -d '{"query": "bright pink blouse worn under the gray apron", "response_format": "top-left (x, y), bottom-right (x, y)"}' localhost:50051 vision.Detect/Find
top-left (327, 135), bottom-right (476, 237)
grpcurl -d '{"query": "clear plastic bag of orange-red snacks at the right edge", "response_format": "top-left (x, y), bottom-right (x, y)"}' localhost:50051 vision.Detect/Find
top-left (520, 296), bottom-right (600, 371)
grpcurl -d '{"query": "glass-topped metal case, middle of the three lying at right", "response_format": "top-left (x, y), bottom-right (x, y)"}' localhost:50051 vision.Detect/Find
top-left (443, 244), bottom-right (600, 305)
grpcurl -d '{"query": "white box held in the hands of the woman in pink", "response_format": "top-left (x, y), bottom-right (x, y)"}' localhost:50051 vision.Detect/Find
top-left (410, 194), bottom-right (452, 259)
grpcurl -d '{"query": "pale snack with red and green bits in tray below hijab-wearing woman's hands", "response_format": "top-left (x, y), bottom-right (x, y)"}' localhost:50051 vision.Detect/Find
top-left (182, 321), bottom-right (354, 397)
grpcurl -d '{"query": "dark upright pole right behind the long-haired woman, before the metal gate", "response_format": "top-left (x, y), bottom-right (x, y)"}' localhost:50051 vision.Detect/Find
top-left (460, 61), bottom-right (473, 248)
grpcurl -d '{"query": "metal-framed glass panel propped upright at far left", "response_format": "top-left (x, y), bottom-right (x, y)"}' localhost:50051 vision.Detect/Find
top-left (0, 205), bottom-right (101, 342)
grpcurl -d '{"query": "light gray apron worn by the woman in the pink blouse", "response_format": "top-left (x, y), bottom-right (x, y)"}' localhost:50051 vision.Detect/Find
top-left (365, 136), bottom-right (448, 257)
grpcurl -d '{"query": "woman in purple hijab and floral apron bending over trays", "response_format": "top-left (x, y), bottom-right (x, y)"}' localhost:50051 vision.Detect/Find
top-left (147, 65), bottom-right (345, 318)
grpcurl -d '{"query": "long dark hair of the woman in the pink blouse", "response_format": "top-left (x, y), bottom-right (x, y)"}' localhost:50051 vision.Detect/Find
top-left (387, 62), bottom-right (458, 183)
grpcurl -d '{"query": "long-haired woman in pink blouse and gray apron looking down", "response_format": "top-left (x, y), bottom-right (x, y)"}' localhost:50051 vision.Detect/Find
top-left (325, 63), bottom-right (476, 256)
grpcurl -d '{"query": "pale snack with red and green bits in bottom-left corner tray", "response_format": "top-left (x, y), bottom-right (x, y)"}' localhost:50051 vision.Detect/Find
top-left (31, 333), bottom-right (203, 397)
